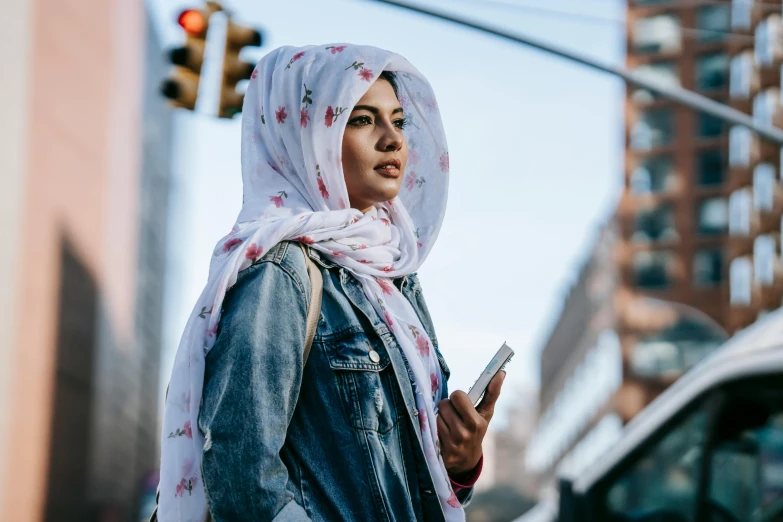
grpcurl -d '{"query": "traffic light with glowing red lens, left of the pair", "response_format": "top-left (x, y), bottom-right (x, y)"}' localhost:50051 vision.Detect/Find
top-left (161, 2), bottom-right (223, 111)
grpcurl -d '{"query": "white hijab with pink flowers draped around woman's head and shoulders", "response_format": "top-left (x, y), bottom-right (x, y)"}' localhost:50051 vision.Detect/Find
top-left (158, 44), bottom-right (465, 522)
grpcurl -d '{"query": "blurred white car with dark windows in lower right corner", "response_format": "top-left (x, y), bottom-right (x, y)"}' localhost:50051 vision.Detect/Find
top-left (515, 310), bottom-right (783, 522)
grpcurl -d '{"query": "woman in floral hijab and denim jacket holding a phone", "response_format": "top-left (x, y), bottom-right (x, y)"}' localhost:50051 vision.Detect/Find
top-left (158, 45), bottom-right (504, 522)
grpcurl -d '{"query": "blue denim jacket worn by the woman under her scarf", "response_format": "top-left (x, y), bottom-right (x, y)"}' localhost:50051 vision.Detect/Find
top-left (199, 242), bottom-right (472, 522)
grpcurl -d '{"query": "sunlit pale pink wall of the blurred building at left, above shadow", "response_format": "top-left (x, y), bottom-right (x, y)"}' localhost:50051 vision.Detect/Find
top-left (0, 0), bottom-right (144, 521)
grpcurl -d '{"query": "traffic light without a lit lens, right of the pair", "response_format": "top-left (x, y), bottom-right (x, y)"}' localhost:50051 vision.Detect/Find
top-left (218, 18), bottom-right (261, 118)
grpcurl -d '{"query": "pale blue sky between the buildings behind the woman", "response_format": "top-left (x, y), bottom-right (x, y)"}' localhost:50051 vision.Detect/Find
top-left (152, 0), bottom-right (625, 428)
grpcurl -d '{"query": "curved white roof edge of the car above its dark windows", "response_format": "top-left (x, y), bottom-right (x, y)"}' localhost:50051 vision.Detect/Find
top-left (574, 309), bottom-right (783, 493)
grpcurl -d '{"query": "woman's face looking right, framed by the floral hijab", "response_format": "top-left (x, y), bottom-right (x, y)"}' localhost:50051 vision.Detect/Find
top-left (343, 79), bottom-right (408, 212)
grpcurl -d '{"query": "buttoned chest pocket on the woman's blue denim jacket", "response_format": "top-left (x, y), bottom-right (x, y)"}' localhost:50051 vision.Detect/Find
top-left (321, 333), bottom-right (400, 433)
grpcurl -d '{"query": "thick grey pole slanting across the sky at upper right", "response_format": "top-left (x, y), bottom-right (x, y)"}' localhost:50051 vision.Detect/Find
top-left (374, 0), bottom-right (783, 146)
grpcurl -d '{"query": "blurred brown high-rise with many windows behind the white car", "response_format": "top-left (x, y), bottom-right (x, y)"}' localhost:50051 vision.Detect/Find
top-left (527, 0), bottom-right (783, 492)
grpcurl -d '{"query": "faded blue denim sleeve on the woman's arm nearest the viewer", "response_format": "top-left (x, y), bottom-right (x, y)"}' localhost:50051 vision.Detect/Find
top-left (199, 261), bottom-right (310, 522)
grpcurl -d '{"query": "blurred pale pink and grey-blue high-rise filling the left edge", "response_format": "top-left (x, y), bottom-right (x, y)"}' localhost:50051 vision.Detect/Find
top-left (0, 0), bottom-right (171, 522)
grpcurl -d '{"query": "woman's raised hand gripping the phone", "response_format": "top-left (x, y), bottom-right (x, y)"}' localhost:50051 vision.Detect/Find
top-left (438, 371), bottom-right (506, 479)
